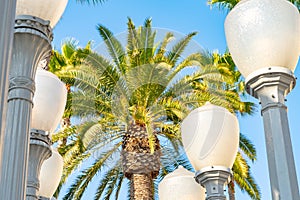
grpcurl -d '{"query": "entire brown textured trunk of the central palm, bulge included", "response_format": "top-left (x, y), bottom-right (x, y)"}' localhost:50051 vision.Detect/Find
top-left (121, 123), bottom-right (161, 200)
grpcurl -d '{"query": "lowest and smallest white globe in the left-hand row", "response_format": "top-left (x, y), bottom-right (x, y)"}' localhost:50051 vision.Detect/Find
top-left (38, 149), bottom-right (64, 198)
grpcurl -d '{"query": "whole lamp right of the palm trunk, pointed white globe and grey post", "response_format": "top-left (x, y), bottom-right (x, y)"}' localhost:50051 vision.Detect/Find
top-left (181, 103), bottom-right (239, 200)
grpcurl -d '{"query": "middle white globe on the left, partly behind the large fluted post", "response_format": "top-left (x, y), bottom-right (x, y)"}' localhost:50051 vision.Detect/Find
top-left (31, 68), bottom-right (67, 133)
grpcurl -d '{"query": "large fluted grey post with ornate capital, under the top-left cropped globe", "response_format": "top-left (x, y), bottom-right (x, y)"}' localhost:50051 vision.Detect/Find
top-left (0, 16), bottom-right (52, 200)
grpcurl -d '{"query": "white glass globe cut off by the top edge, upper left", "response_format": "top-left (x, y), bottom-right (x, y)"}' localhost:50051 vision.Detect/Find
top-left (16, 0), bottom-right (68, 28)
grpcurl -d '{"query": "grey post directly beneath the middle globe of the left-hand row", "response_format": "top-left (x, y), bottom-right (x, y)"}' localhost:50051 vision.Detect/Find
top-left (26, 129), bottom-right (52, 200)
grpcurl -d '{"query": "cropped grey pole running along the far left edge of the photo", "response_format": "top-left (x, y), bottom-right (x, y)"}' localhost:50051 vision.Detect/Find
top-left (0, 0), bottom-right (16, 176)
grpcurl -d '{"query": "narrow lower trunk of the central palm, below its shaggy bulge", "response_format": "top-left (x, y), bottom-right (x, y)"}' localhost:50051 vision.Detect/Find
top-left (130, 174), bottom-right (153, 200)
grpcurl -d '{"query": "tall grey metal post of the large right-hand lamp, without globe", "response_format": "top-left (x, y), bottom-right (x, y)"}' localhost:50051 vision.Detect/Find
top-left (247, 67), bottom-right (300, 200)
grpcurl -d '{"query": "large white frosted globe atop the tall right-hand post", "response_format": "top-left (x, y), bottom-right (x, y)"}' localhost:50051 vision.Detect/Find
top-left (225, 0), bottom-right (300, 78)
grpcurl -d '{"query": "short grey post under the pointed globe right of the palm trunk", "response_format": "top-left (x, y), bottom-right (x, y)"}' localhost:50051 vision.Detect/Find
top-left (195, 166), bottom-right (231, 200)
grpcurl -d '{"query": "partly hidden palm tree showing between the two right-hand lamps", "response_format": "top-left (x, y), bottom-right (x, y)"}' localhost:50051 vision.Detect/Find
top-left (191, 52), bottom-right (260, 200)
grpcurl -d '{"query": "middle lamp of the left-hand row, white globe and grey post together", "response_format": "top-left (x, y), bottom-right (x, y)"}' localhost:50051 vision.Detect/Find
top-left (26, 68), bottom-right (67, 200)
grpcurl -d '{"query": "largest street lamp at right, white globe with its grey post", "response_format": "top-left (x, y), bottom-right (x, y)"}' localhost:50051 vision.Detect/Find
top-left (225, 0), bottom-right (300, 200)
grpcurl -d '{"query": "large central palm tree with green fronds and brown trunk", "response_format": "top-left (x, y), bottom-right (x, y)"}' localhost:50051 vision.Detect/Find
top-left (51, 19), bottom-right (253, 199)
